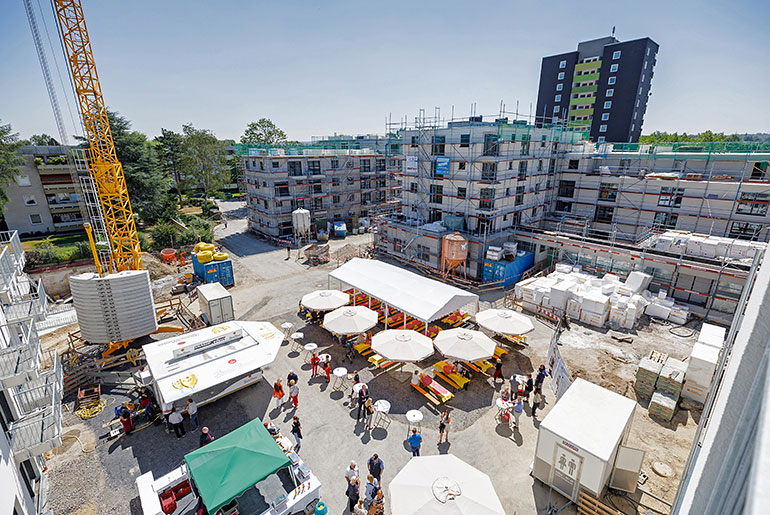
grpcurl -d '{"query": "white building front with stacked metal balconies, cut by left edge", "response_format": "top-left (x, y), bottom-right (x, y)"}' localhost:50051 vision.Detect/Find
top-left (0, 231), bottom-right (63, 515)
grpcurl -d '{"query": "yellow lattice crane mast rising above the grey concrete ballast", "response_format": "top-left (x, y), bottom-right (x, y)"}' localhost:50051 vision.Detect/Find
top-left (53, 0), bottom-right (142, 272)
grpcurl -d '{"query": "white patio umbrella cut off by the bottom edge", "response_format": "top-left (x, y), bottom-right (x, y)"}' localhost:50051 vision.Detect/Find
top-left (388, 454), bottom-right (505, 515)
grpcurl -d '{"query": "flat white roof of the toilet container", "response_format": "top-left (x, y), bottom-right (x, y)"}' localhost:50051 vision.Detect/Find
top-left (540, 378), bottom-right (636, 461)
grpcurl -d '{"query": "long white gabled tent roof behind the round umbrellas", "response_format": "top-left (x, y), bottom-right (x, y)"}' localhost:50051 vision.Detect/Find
top-left (329, 258), bottom-right (479, 322)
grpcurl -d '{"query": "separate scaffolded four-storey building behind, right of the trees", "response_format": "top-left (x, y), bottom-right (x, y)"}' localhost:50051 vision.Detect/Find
top-left (236, 140), bottom-right (400, 238)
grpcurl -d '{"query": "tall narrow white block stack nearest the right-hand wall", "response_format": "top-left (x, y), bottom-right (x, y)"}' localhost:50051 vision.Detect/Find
top-left (682, 324), bottom-right (726, 404)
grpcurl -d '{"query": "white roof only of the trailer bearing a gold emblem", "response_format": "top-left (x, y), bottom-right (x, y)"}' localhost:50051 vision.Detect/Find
top-left (142, 320), bottom-right (283, 402)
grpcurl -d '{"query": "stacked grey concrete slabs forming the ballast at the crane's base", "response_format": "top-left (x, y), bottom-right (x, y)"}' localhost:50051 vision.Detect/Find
top-left (69, 270), bottom-right (158, 343)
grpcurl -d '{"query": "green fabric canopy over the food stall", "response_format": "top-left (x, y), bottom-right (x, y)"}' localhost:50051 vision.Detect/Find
top-left (184, 418), bottom-right (291, 513)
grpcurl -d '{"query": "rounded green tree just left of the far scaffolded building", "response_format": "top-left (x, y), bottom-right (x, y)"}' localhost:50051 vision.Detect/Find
top-left (182, 124), bottom-right (230, 214)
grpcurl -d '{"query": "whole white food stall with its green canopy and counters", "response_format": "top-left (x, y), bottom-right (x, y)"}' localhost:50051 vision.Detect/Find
top-left (136, 418), bottom-right (321, 515)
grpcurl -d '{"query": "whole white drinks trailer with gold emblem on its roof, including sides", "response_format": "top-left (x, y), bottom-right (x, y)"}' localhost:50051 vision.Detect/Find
top-left (141, 320), bottom-right (283, 406)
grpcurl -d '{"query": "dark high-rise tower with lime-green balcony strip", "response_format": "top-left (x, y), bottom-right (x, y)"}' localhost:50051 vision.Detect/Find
top-left (536, 37), bottom-right (659, 143)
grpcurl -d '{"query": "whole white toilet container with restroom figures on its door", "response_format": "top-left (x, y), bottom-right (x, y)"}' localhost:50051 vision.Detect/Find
top-left (532, 378), bottom-right (636, 501)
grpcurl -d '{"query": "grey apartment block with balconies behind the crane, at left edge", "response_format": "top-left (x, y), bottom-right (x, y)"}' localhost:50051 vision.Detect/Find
top-left (4, 145), bottom-right (84, 235)
